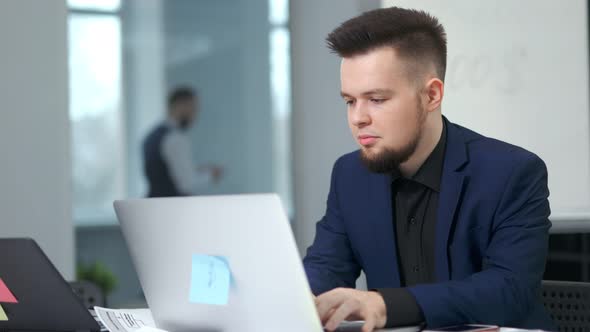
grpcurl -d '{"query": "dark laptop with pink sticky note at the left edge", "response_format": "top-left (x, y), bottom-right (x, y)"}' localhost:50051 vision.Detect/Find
top-left (0, 239), bottom-right (100, 331)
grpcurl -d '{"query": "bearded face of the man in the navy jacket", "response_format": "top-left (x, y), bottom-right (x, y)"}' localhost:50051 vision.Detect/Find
top-left (340, 47), bottom-right (426, 173)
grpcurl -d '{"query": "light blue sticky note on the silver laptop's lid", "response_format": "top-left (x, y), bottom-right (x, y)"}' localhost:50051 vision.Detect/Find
top-left (189, 254), bottom-right (231, 305)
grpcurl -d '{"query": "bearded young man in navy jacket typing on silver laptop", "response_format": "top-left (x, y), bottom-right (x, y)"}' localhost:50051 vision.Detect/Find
top-left (304, 7), bottom-right (554, 331)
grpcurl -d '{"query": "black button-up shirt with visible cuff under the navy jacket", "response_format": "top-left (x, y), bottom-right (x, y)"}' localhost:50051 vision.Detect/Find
top-left (376, 122), bottom-right (446, 327)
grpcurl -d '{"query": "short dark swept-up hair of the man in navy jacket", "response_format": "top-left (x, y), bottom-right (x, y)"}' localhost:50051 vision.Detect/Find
top-left (326, 7), bottom-right (447, 81)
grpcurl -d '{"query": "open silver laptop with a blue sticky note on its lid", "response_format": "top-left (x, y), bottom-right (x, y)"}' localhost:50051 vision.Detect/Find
top-left (114, 194), bottom-right (323, 332)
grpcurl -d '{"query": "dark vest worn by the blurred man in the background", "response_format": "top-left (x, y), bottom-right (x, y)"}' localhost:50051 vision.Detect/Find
top-left (143, 124), bottom-right (184, 197)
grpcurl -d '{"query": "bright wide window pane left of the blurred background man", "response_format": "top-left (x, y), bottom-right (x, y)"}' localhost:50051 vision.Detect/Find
top-left (68, 0), bottom-right (126, 224)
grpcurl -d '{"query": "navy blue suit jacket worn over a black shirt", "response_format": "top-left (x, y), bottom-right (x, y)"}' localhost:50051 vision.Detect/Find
top-left (304, 119), bottom-right (555, 330)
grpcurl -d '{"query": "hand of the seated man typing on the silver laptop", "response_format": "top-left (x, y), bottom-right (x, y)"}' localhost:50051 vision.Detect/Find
top-left (315, 288), bottom-right (387, 332)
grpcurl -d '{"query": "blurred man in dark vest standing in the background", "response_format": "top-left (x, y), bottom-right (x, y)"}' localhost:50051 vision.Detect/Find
top-left (143, 87), bottom-right (221, 197)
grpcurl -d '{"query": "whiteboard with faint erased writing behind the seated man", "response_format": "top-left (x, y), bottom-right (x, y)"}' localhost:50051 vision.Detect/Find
top-left (383, 0), bottom-right (590, 220)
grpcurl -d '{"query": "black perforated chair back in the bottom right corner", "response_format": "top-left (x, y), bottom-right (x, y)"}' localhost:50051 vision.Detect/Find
top-left (541, 280), bottom-right (590, 332)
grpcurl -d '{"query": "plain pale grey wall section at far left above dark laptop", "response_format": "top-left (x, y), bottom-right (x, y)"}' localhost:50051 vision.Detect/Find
top-left (0, 0), bottom-right (74, 279)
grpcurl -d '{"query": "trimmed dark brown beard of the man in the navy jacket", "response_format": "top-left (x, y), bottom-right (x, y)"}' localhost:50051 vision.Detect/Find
top-left (360, 104), bottom-right (426, 174)
